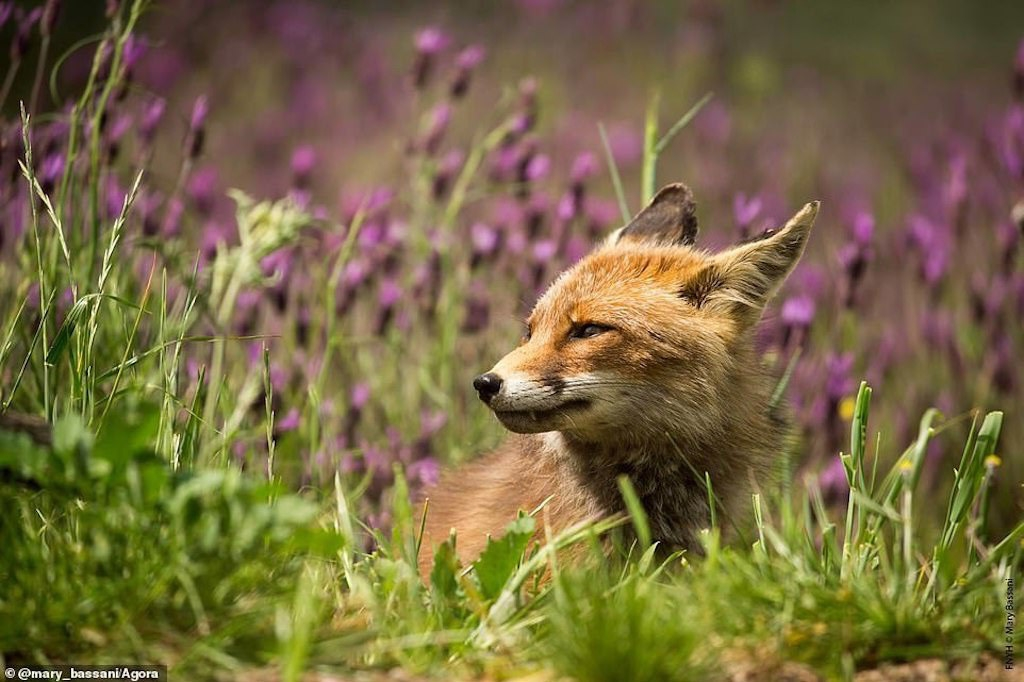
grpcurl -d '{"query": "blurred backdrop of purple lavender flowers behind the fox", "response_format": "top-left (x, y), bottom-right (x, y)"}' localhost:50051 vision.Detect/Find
top-left (0, 0), bottom-right (1024, 527)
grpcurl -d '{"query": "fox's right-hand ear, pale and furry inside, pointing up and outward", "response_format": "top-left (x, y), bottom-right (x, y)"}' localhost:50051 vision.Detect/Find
top-left (680, 202), bottom-right (818, 325)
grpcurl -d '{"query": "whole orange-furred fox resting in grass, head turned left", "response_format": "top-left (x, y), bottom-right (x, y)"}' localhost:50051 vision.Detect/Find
top-left (419, 183), bottom-right (819, 577)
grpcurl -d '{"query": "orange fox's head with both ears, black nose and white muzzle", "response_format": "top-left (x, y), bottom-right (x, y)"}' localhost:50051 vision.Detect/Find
top-left (473, 184), bottom-right (818, 442)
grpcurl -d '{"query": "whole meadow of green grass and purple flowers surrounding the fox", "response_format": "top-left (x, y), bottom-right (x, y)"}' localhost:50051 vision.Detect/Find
top-left (0, 0), bottom-right (1024, 680)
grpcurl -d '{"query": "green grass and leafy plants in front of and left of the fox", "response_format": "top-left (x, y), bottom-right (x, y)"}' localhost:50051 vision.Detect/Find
top-left (0, 3), bottom-right (1024, 680)
